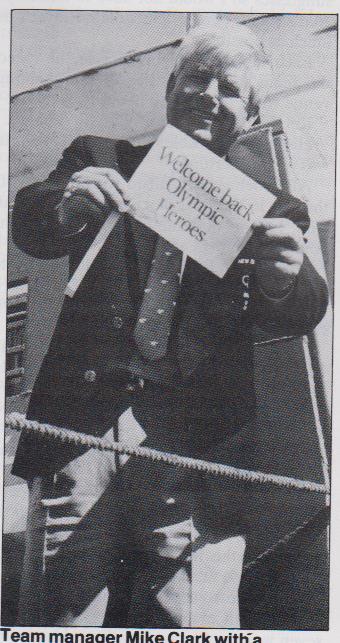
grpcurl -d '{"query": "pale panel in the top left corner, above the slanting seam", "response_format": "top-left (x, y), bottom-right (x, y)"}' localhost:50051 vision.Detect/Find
top-left (12, 10), bottom-right (186, 94)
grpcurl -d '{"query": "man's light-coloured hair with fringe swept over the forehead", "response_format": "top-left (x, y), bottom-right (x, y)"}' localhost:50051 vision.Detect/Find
top-left (173, 20), bottom-right (272, 108)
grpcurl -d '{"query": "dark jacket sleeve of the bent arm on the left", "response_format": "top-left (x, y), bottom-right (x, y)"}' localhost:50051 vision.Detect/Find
top-left (12, 137), bottom-right (105, 259)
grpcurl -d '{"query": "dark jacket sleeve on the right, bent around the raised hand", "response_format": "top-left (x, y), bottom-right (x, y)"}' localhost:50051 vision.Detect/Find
top-left (251, 193), bottom-right (328, 335)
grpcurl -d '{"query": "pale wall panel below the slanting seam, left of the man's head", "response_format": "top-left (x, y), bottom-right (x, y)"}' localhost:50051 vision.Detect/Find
top-left (10, 47), bottom-right (175, 198)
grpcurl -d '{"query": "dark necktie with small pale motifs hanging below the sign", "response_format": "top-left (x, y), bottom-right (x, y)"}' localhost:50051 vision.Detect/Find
top-left (134, 237), bottom-right (182, 360)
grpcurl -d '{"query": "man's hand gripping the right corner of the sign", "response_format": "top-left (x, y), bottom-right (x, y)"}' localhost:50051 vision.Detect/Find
top-left (253, 218), bottom-right (304, 299)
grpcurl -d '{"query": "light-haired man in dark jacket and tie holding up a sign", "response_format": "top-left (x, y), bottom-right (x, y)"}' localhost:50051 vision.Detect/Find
top-left (13, 23), bottom-right (327, 627)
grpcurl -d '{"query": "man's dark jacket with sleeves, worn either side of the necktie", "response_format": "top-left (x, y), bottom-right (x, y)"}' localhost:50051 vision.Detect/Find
top-left (12, 136), bottom-right (327, 476)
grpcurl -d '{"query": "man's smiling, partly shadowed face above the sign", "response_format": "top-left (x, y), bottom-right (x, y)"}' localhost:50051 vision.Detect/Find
top-left (167, 57), bottom-right (254, 156)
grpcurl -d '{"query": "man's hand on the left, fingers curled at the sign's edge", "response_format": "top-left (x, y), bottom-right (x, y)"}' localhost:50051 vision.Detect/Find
top-left (60, 167), bottom-right (130, 214)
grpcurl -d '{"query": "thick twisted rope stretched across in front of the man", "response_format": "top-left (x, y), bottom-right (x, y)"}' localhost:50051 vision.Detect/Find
top-left (5, 413), bottom-right (329, 494)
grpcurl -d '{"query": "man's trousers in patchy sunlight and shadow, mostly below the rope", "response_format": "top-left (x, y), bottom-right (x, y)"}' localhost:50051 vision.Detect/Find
top-left (18, 408), bottom-right (245, 628)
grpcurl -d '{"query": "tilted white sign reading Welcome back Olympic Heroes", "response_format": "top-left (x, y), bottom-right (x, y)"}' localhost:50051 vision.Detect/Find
top-left (129, 125), bottom-right (276, 277)
